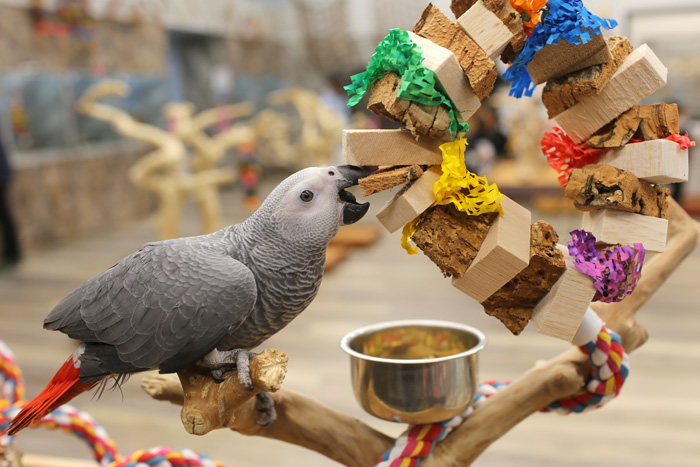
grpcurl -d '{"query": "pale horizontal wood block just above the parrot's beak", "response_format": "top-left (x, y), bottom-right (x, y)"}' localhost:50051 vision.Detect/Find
top-left (342, 130), bottom-right (444, 165)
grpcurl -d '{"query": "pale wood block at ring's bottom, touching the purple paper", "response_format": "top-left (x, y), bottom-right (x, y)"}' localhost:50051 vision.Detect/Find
top-left (532, 245), bottom-right (595, 342)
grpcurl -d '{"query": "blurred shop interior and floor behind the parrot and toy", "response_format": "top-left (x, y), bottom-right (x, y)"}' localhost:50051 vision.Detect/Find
top-left (0, 0), bottom-right (700, 466)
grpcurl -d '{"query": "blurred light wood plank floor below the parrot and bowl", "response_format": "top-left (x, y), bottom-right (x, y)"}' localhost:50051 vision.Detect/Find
top-left (0, 177), bottom-right (700, 467)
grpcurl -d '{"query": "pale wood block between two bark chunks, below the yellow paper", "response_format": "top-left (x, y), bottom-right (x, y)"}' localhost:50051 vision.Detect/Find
top-left (452, 196), bottom-right (531, 303)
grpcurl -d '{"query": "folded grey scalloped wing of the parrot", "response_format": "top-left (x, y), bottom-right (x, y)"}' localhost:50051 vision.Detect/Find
top-left (44, 238), bottom-right (257, 380)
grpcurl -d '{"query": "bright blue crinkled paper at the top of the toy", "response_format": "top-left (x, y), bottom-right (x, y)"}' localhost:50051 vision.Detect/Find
top-left (504, 0), bottom-right (617, 98)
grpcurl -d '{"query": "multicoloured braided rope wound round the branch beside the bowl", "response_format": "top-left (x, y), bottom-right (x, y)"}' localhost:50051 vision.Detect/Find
top-left (375, 326), bottom-right (629, 467)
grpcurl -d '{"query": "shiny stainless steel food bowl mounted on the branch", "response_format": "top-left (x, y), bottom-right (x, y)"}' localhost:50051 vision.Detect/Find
top-left (340, 320), bottom-right (487, 424)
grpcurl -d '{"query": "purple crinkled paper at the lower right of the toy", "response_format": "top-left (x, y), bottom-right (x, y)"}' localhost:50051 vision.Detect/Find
top-left (567, 230), bottom-right (645, 303)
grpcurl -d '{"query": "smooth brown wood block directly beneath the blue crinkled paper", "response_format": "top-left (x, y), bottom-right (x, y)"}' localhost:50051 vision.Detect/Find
top-left (527, 34), bottom-right (612, 84)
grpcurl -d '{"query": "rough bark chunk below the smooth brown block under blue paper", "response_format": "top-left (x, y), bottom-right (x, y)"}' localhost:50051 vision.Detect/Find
top-left (542, 36), bottom-right (632, 118)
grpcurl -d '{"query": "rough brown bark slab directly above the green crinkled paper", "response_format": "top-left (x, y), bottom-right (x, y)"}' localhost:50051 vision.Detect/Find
top-left (413, 3), bottom-right (498, 100)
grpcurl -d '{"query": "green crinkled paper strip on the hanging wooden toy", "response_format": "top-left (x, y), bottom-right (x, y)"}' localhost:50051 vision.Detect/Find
top-left (345, 29), bottom-right (469, 137)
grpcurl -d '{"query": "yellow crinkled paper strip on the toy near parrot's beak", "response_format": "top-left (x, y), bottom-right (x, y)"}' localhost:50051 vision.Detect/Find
top-left (401, 137), bottom-right (503, 255)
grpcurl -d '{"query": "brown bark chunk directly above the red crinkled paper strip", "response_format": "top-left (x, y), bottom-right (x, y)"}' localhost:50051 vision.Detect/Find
top-left (586, 103), bottom-right (680, 149)
